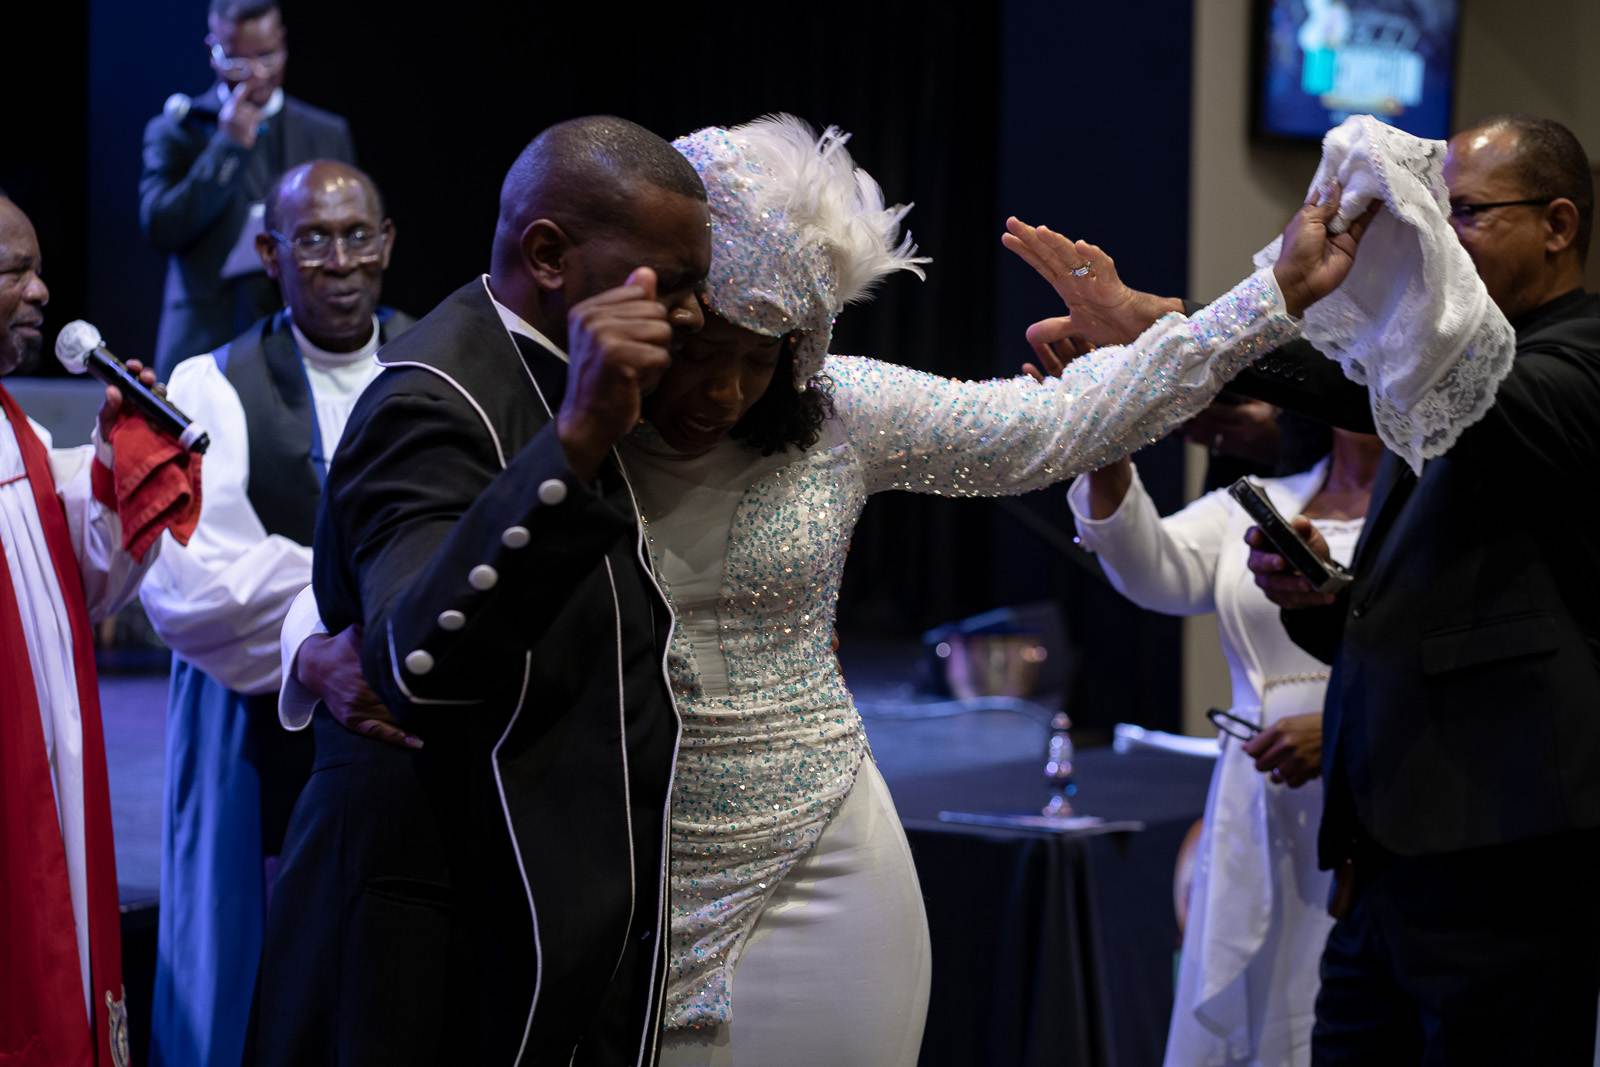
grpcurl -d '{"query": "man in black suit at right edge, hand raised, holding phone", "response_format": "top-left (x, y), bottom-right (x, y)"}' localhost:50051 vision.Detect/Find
top-left (1035, 115), bottom-right (1600, 1067)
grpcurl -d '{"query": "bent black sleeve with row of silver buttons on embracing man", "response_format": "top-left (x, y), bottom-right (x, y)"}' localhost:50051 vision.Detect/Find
top-left (326, 385), bottom-right (637, 717)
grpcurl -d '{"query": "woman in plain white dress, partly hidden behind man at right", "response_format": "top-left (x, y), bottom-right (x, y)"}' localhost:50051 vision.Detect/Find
top-left (1067, 430), bottom-right (1382, 1067)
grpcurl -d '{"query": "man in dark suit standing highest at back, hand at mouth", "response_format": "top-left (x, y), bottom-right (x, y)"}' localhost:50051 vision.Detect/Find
top-left (139, 0), bottom-right (355, 376)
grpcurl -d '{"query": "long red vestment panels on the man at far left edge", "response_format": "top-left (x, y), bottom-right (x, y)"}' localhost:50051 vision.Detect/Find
top-left (0, 379), bottom-right (128, 1067)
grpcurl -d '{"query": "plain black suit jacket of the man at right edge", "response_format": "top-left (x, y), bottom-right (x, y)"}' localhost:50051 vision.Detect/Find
top-left (1232, 291), bottom-right (1600, 865)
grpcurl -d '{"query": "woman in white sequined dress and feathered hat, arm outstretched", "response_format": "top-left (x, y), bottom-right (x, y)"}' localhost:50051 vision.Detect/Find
top-left (640, 117), bottom-right (1360, 1067)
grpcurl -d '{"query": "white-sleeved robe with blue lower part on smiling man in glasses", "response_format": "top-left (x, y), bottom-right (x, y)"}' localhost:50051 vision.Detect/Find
top-left (141, 313), bottom-right (381, 1067)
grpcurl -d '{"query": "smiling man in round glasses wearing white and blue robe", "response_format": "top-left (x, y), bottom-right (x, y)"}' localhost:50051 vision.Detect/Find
top-left (142, 160), bottom-right (411, 1067)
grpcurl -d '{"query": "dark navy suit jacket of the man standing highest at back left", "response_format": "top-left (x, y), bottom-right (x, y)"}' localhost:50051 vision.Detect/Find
top-left (139, 86), bottom-right (355, 379)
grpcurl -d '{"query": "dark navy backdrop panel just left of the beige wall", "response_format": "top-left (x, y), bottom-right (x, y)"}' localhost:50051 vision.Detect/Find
top-left (989, 0), bottom-right (1196, 736)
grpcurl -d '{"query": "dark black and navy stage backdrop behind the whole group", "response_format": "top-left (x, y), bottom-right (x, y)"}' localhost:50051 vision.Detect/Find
top-left (0, 0), bottom-right (1203, 728)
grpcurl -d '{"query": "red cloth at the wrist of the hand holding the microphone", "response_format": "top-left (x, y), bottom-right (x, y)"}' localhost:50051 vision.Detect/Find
top-left (93, 414), bottom-right (200, 563)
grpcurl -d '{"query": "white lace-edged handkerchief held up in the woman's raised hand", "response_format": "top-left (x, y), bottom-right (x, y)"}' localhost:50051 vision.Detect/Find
top-left (1256, 115), bottom-right (1517, 474)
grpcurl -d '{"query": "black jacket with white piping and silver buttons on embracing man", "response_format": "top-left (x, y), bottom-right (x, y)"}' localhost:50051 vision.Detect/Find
top-left (258, 280), bottom-right (677, 1067)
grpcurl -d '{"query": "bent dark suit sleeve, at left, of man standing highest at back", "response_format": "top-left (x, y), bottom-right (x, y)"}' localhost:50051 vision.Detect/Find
top-left (139, 115), bottom-right (249, 253)
